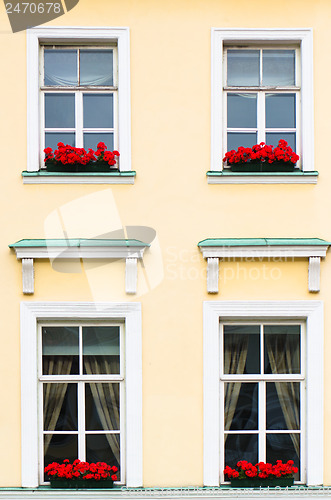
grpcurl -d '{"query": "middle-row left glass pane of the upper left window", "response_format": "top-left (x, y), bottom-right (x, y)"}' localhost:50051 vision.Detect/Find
top-left (45, 94), bottom-right (75, 128)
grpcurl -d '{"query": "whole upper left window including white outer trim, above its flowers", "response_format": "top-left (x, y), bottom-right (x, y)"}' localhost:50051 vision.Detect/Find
top-left (27, 27), bottom-right (132, 176)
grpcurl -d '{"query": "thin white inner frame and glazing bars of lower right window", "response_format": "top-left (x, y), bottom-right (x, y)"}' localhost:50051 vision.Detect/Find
top-left (220, 319), bottom-right (306, 484)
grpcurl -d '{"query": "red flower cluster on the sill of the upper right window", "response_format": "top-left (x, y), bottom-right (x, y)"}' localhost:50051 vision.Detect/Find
top-left (223, 139), bottom-right (299, 165)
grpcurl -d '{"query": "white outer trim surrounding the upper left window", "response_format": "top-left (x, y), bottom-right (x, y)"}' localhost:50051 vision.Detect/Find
top-left (27, 27), bottom-right (131, 176)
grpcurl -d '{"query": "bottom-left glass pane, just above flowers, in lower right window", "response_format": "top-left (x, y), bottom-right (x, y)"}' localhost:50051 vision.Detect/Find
top-left (224, 434), bottom-right (258, 467)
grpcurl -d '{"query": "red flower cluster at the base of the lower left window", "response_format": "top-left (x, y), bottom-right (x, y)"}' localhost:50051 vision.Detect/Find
top-left (44, 458), bottom-right (118, 481)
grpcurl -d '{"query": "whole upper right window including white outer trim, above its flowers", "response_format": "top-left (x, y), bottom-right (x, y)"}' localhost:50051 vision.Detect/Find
top-left (211, 28), bottom-right (314, 172)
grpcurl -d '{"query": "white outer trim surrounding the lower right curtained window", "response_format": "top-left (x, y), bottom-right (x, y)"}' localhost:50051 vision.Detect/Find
top-left (203, 300), bottom-right (324, 486)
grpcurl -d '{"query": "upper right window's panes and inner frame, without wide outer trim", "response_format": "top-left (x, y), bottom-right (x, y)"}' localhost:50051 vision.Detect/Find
top-left (223, 46), bottom-right (301, 167)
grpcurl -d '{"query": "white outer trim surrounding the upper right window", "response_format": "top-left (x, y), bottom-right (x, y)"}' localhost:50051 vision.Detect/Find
top-left (210, 28), bottom-right (314, 176)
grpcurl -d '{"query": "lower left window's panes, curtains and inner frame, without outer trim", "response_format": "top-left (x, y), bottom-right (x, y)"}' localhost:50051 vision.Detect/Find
top-left (39, 323), bottom-right (125, 483)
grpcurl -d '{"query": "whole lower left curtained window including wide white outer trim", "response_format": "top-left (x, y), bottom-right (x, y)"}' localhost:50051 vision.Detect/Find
top-left (21, 302), bottom-right (142, 488)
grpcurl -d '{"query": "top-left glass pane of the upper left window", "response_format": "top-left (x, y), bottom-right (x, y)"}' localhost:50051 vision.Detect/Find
top-left (44, 49), bottom-right (78, 87)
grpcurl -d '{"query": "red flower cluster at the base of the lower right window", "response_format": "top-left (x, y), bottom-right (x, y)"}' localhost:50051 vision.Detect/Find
top-left (223, 460), bottom-right (298, 479)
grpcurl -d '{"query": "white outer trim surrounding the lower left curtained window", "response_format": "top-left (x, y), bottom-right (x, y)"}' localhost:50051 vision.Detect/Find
top-left (21, 302), bottom-right (143, 488)
